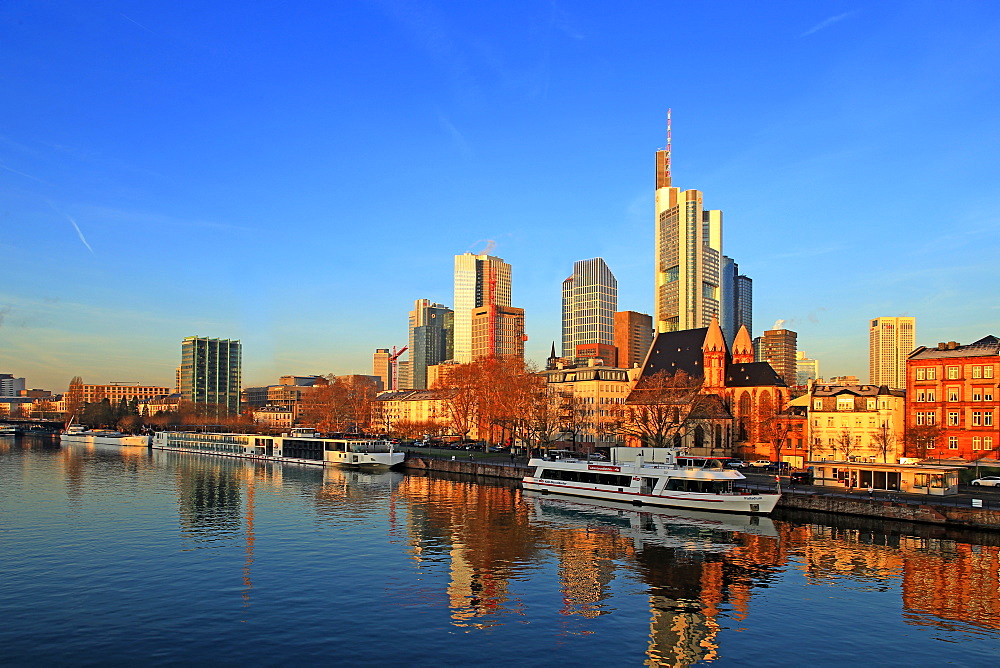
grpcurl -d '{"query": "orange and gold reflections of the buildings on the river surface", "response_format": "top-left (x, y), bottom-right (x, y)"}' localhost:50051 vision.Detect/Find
top-left (7, 434), bottom-right (1000, 664)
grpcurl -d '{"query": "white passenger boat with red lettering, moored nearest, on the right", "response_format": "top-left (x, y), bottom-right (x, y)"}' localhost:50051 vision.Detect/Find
top-left (522, 448), bottom-right (781, 515)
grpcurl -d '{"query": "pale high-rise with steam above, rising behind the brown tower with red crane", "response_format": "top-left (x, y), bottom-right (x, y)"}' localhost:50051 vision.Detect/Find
top-left (454, 253), bottom-right (523, 364)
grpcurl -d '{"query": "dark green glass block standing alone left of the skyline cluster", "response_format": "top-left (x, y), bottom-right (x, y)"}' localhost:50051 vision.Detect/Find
top-left (181, 336), bottom-right (243, 415)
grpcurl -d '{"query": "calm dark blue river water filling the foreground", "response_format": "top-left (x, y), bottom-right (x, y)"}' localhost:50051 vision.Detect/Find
top-left (0, 437), bottom-right (1000, 666)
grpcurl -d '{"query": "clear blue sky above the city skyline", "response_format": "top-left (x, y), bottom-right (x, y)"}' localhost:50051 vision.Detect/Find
top-left (0, 0), bottom-right (1000, 391)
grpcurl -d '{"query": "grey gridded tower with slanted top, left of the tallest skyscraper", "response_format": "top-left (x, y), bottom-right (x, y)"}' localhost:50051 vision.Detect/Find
top-left (562, 257), bottom-right (618, 358)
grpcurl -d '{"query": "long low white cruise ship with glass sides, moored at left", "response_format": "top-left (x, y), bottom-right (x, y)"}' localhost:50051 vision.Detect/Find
top-left (153, 428), bottom-right (406, 469)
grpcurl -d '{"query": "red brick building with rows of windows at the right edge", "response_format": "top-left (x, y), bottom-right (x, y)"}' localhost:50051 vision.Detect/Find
top-left (906, 336), bottom-right (1000, 461)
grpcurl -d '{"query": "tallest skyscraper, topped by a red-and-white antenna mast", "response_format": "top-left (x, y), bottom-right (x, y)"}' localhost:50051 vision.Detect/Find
top-left (654, 112), bottom-right (722, 332)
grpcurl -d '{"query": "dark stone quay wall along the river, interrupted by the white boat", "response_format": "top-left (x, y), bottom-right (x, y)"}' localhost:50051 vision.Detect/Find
top-left (401, 452), bottom-right (1000, 531)
